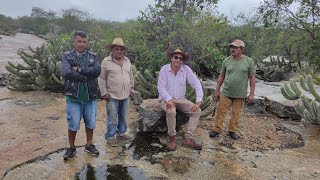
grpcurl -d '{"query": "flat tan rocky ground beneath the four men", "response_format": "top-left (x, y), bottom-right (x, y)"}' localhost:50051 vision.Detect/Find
top-left (0, 34), bottom-right (320, 179)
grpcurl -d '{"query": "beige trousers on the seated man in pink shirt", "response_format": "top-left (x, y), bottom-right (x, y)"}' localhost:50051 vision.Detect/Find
top-left (160, 99), bottom-right (201, 138)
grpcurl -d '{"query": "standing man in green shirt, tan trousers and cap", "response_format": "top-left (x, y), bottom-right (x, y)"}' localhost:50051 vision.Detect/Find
top-left (209, 39), bottom-right (256, 140)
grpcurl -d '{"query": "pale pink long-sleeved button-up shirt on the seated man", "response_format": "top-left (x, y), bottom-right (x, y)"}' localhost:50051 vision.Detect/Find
top-left (157, 64), bottom-right (203, 102)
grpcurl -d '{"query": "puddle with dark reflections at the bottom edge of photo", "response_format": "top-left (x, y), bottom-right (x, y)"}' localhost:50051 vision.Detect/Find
top-left (75, 164), bottom-right (148, 180)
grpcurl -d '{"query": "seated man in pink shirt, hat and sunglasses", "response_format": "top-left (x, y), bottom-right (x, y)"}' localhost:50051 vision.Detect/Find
top-left (157, 49), bottom-right (203, 151)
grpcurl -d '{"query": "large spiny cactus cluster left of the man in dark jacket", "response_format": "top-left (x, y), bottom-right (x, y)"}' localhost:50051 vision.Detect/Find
top-left (5, 44), bottom-right (63, 91)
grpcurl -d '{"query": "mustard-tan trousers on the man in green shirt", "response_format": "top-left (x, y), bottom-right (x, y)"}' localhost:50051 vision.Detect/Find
top-left (213, 94), bottom-right (243, 132)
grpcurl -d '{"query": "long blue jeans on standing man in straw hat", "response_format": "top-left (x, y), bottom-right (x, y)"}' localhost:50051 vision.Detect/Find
top-left (105, 98), bottom-right (129, 139)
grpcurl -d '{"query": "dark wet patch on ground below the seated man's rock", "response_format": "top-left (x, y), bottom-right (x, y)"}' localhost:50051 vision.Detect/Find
top-left (133, 133), bottom-right (169, 160)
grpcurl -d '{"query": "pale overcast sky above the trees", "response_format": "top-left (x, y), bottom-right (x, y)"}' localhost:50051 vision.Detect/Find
top-left (0, 0), bottom-right (262, 21)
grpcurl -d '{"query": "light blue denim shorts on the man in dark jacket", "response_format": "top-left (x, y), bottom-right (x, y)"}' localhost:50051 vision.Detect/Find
top-left (66, 99), bottom-right (98, 131)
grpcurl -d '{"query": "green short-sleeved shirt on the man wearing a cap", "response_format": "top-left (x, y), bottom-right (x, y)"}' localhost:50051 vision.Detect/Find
top-left (221, 55), bottom-right (256, 98)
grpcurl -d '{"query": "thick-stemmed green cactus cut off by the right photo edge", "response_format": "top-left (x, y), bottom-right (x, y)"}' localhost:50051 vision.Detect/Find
top-left (281, 75), bottom-right (320, 126)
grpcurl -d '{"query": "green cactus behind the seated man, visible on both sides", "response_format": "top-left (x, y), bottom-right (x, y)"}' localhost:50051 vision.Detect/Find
top-left (132, 65), bottom-right (216, 118)
